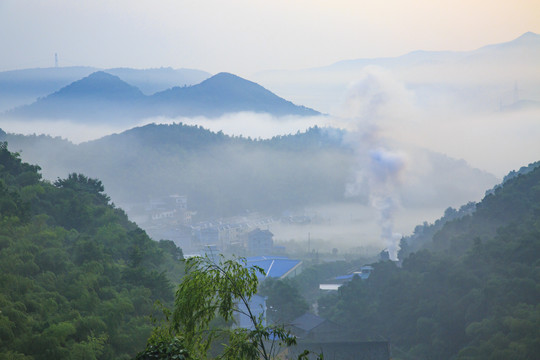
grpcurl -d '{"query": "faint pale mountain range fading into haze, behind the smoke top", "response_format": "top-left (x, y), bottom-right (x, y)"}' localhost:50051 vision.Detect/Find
top-left (253, 32), bottom-right (540, 114)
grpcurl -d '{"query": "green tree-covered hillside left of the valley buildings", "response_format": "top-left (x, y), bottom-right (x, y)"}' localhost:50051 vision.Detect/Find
top-left (0, 143), bottom-right (182, 360)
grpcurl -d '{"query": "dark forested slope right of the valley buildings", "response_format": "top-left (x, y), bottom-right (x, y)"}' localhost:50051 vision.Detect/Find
top-left (319, 165), bottom-right (540, 359)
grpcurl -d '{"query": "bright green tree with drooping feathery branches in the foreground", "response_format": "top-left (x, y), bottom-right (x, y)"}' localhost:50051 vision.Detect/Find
top-left (137, 257), bottom-right (296, 359)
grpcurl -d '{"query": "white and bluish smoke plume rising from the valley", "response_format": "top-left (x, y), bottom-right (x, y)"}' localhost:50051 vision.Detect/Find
top-left (343, 68), bottom-right (412, 260)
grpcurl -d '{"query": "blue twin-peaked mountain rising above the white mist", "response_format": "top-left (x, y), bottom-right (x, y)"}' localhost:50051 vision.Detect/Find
top-left (2, 71), bottom-right (319, 122)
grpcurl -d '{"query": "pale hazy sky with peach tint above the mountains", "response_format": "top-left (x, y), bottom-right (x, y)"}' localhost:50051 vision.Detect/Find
top-left (0, 0), bottom-right (540, 76)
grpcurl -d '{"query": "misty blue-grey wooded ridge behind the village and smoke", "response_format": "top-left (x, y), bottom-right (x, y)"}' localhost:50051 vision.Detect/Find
top-left (0, 123), bottom-right (497, 219)
